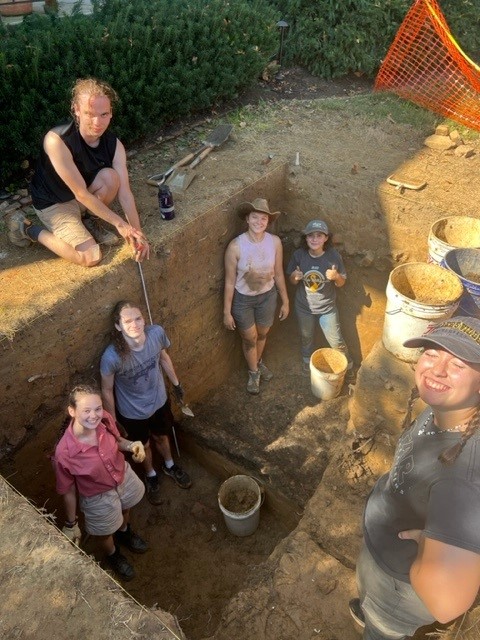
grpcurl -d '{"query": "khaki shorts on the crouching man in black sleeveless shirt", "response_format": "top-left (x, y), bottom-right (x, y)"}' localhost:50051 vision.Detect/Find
top-left (35, 200), bottom-right (92, 249)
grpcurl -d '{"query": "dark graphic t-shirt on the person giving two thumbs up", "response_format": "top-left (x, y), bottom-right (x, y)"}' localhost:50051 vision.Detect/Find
top-left (287, 248), bottom-right (346, 315)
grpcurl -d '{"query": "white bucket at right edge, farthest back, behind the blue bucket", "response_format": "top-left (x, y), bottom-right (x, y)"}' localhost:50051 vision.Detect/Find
top-left (428, 216), bottom-right (480, 264)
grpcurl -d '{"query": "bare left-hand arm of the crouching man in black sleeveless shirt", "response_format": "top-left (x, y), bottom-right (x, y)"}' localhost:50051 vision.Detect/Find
top-left (43, 131), bottom-right (145, 256)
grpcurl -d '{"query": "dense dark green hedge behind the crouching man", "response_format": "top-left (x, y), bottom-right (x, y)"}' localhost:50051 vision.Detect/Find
top-left (0, 0), bottom-right (278, 185)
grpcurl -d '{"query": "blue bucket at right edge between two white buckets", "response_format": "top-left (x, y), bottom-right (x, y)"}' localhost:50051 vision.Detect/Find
top-left (442, 249), bottom-right (480, 318)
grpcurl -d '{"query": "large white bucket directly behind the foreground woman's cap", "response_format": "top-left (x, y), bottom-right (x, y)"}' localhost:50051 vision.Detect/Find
top-left (382, 262), bottom-right (463, 362)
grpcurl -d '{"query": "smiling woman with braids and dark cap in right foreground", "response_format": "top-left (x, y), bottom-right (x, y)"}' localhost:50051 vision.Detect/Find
top-left (350, 317), bottom-right (480, 640)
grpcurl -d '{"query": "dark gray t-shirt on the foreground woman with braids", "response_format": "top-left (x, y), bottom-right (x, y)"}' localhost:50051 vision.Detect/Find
top-left (363, 409), bottom-right (480, 582)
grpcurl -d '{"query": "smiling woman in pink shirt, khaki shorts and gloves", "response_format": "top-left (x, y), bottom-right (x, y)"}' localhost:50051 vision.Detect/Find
top-left (53, 385), bottom-right (148, 580)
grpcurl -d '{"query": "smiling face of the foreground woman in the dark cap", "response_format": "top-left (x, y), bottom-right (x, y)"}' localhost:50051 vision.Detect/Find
top-left (415, 346), bottom-right (480, 411)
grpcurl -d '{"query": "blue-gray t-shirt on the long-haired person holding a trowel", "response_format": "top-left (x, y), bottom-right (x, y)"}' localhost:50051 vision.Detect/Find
top-left (100, 324), bottom-right (170, 420)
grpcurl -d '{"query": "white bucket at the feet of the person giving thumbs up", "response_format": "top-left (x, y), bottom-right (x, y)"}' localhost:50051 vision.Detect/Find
top-left (310, 349), bottom-right (348, 400)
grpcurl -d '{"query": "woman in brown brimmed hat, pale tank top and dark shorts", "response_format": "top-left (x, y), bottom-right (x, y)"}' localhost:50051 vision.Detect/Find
top-left (223, 198), bottom-right (289, 394)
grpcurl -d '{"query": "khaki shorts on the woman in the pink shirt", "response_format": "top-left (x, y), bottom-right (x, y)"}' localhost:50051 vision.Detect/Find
top-left (79, 461), bottom-right (145, 536)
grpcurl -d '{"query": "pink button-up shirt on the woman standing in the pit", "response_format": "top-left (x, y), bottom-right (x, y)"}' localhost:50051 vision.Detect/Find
top-left (53, 411), bottom-right (125, 496)
